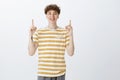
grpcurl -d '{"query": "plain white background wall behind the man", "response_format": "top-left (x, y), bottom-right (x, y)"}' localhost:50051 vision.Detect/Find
top-left (0, 0), bottom-right (120, 80)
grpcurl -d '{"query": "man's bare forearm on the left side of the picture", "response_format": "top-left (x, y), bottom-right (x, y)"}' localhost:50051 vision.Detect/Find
top-left (28, 36), bottom-right (36, 56)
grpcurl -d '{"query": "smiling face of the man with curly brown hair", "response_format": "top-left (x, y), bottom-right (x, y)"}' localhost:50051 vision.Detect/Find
top-left (46, 10), bottom-right (59, 23)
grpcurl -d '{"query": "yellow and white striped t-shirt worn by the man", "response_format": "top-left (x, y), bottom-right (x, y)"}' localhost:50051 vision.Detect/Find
top-left (33, 28), bottom-right (69, 77)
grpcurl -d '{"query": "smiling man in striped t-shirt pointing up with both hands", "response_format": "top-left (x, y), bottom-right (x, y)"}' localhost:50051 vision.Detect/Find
top-left (28, 4), bottom-right (74, 80)
